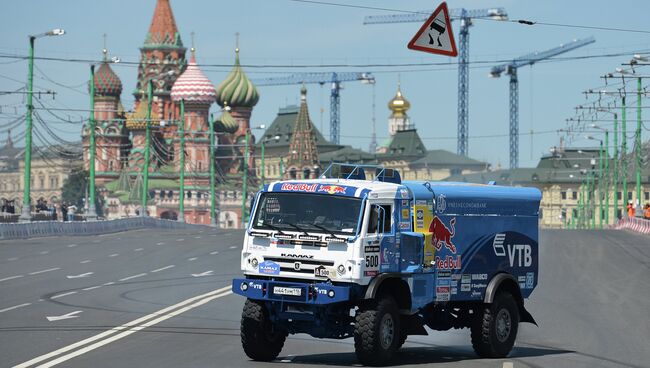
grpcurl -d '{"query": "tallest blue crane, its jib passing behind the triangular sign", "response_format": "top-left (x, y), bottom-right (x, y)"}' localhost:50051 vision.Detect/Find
top-left (363, 8), bottom-right (508, 156)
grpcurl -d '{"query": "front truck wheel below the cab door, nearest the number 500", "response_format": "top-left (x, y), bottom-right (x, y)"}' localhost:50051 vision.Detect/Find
top-left (354, 296), bottom-right (402, 366)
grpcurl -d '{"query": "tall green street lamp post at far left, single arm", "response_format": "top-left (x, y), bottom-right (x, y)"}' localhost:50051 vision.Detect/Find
top-left (18, 28), bottom-right (65, 222)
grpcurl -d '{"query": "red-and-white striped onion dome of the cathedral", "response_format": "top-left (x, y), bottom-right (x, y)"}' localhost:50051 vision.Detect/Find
top-left (171, 49), bottom-right (217, 105)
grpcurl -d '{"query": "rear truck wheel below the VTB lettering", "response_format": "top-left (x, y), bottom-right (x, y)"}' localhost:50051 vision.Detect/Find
top-left (471, 292), bottom-right (519, 358)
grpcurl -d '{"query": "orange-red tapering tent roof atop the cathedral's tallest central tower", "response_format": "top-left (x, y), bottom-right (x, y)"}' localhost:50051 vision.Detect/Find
top-left (143, 0), bottom-right (183, 48)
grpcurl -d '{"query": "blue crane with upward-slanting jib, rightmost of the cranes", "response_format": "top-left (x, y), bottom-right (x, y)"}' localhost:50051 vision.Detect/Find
top-left (490, 37), bottom-right (596, 169)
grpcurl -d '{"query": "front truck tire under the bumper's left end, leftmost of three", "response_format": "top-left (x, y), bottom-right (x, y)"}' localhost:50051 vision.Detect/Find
top-left (241, 299), bottom-right (287, 362)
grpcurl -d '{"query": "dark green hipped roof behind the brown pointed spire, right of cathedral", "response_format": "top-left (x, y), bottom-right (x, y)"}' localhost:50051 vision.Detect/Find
top-left (256, 105), bottom-right (344, 156)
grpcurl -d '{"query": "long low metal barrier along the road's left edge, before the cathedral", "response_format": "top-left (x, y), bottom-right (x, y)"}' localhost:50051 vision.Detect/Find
top-left (0, 217), bottom-right (207, 240)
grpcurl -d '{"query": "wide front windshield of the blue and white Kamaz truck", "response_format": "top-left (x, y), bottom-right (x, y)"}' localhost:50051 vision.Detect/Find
top-left (253, 193), bottom-right (362, 235)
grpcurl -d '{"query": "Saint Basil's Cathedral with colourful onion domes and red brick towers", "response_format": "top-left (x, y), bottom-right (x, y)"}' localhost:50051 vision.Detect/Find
top-left (82, 0), bottom-right (260, 227)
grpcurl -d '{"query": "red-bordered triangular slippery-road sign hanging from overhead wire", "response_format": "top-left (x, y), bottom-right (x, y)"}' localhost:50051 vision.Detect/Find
top-left (408, 2), bottom-right (458, 56)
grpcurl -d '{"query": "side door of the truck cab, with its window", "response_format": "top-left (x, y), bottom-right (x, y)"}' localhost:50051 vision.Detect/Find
top-left (364, 201), bottom-right (398, 276)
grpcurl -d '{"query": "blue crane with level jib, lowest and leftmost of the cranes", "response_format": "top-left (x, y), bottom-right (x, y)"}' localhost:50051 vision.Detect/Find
top-left (253, 72), bottom-right (375, 144)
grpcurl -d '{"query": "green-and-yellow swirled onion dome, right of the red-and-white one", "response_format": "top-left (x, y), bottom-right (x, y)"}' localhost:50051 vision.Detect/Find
top-left (217, 48), bottom-right (260, 107)
